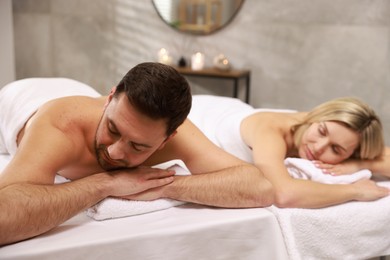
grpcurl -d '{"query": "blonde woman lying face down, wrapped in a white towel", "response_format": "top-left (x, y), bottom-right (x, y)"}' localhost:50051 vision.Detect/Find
top-left (189, 96), bottom-right (390, 208)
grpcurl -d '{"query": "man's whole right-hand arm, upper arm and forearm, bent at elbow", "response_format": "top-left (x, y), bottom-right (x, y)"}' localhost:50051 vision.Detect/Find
top-left (143, 120), bottom-right (273, 208)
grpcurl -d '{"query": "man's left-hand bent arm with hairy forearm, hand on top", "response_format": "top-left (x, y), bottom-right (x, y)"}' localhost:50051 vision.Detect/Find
top-left (0, 105), bottom-right (173, 245)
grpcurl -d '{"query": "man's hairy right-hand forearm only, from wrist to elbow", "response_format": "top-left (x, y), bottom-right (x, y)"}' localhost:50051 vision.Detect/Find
top-left (162, 165), bottom-right (273, 208)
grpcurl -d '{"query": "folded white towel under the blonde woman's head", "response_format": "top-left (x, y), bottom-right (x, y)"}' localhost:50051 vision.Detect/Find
top-left (284, 158), bottom-right (372, 184)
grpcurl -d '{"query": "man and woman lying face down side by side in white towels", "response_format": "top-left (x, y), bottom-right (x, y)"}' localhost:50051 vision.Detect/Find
top-left (0, 63), bottom-right (390, 244)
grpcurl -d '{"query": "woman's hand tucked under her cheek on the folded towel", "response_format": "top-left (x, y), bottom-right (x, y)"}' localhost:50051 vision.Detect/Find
top-left (313, 160), bottom-right (362, 176)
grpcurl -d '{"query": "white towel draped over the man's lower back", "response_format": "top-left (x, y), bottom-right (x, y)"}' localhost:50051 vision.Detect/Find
top-left (0, 78), bottom-right (100, 155)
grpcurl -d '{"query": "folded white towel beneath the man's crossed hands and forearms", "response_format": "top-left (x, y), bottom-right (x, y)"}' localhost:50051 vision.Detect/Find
top-left (86, 160), bottom-right (190, 220)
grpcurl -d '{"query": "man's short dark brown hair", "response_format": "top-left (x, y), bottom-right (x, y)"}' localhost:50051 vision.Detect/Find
top-left (114, 62), bottom-right (192, 136)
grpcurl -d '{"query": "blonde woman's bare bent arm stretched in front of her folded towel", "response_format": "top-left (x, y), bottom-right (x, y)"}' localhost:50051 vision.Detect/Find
top-left (242, 112), bottom-right (389, 208)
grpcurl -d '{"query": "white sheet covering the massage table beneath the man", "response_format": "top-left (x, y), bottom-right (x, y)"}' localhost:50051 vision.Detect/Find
top-left (0, 155), bottom-right (288, 260)
